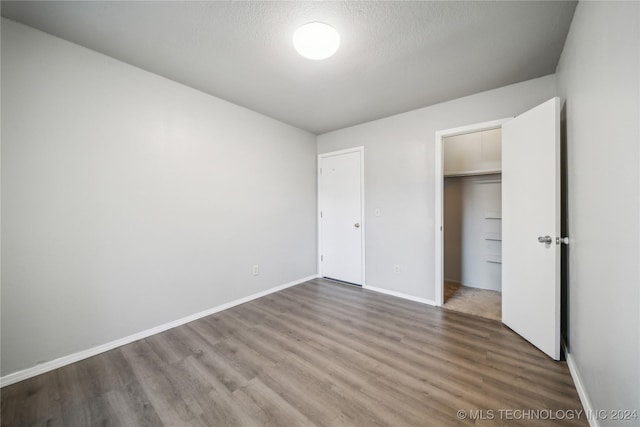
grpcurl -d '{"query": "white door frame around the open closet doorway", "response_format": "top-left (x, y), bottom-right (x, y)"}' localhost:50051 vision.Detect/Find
top-left (434, 117), bottom-right (513, 307)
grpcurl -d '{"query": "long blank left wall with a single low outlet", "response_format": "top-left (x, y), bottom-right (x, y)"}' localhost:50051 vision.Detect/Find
top-left (2, 19), bottom-right (317, 375)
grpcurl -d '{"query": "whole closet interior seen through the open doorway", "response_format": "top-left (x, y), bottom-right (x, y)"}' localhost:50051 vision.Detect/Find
top-left (443, 128), bottom-right (502, 320)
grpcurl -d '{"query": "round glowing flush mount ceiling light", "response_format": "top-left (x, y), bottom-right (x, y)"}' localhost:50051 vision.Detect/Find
top-left (293, 22), bottom-right (340, 60)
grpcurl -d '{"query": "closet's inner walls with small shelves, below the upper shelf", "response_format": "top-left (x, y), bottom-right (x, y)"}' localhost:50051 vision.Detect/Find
top-left (442, 174), bottom-right (502, 291)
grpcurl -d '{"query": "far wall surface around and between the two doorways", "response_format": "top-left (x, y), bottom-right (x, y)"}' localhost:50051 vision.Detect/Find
top-left (318, 75), bottom-right (556, 301)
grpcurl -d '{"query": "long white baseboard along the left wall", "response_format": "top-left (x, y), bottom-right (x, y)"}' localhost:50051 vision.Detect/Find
top-left (0, 274), bottom-right (318, 388)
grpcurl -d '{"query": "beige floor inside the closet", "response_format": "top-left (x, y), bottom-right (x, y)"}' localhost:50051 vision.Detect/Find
top-left (442, 281), bottom-right (502, 321)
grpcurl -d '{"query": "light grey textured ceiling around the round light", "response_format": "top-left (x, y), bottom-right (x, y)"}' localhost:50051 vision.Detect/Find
top-left (2, 1), bottom-right (575, 134)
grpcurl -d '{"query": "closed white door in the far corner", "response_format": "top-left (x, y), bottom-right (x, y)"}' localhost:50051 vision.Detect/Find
top-left (319, 148), bottom-right (364, 285)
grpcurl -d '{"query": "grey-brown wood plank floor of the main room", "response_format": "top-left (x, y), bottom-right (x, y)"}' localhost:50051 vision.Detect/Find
top-left (1, 280), bottom-right (587, 427)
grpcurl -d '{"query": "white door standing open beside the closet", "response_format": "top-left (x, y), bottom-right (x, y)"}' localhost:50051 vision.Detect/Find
top-left (502, 98), bottom-right (560, 360)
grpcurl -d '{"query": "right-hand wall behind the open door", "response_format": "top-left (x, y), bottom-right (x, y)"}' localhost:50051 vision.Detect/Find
top-left (557, 2), bottom-right (640, 425)
